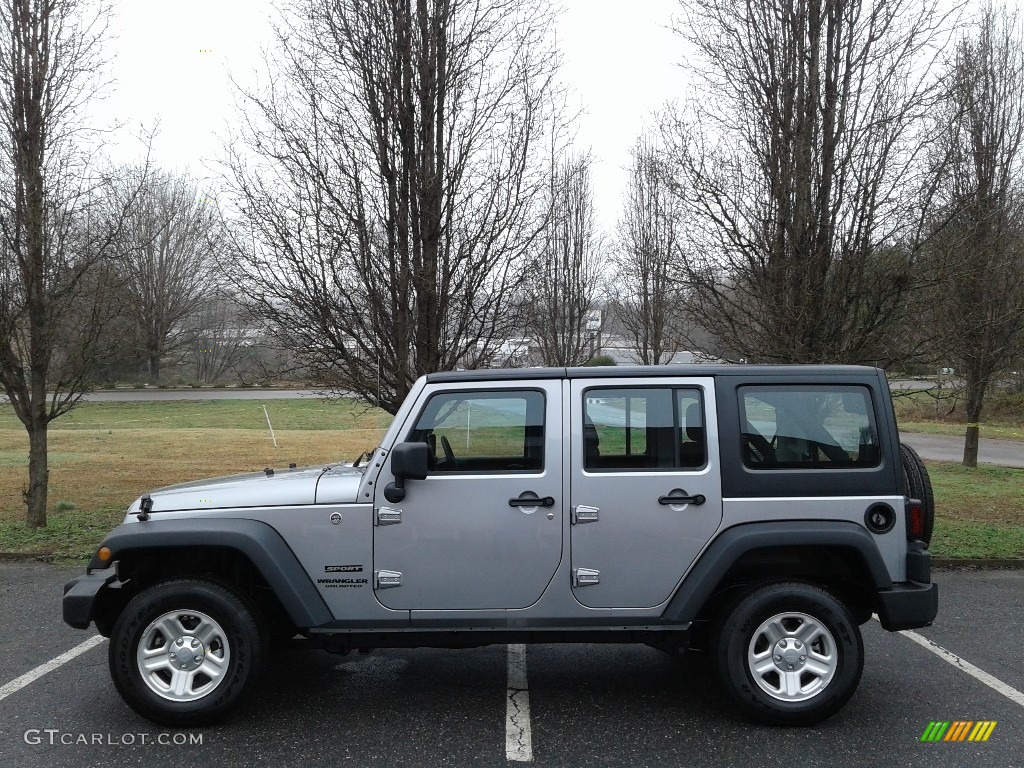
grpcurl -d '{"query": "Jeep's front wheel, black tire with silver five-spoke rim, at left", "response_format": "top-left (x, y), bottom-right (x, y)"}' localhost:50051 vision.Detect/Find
top-left (109, 579), bottom-right (266, 727)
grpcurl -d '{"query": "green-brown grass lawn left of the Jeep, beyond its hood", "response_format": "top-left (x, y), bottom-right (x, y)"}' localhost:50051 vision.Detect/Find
top-left (0, 399), bottom-right (391, 560)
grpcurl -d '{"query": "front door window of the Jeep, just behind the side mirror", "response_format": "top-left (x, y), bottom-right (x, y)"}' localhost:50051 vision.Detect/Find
top-left (407, 390), bottom-right (544, 472)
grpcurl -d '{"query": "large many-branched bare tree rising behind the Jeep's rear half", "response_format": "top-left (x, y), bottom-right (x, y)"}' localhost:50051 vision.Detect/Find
top-left (665, 0), bottom-right (947, 362)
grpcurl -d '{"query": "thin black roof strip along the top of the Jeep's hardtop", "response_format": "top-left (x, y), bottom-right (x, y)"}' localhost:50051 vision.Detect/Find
top-left (427, 364), bottom-right (880, 382)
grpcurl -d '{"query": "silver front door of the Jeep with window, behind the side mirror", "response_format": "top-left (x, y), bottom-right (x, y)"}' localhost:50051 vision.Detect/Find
top-left (374, 380), bottom-right (565, 610)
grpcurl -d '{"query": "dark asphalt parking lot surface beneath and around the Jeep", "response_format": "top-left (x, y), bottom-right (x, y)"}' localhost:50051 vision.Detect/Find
top-left (0, 562), bottom-right (1024, 768)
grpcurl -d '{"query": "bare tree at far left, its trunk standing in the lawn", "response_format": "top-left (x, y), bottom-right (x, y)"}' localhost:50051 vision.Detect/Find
top-left (0, 0), bottom-right (143, 527)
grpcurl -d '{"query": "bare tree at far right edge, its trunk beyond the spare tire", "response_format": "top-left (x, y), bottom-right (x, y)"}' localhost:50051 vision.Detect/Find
top-left (931, 4), bottom-right (1024, 467)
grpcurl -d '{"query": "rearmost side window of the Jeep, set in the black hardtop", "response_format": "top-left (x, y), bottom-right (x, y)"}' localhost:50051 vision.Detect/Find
top-left (739, 386), bottom-right (879, 469)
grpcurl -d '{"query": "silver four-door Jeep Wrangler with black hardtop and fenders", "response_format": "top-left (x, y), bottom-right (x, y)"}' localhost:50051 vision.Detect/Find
top-left (63, 366), bottom-right (938, 726)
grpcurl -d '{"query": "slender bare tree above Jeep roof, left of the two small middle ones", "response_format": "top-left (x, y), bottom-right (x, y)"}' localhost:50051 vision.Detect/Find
top-left (527, 154), bottom-right (600, 366)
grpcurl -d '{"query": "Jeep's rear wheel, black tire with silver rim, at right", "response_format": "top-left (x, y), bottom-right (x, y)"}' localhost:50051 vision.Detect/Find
top-left (716, 582), bottom-right (864, 725)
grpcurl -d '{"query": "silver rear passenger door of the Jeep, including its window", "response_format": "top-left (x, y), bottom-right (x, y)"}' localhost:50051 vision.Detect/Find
top-left (569, 378), bottom-right (722, 608)
